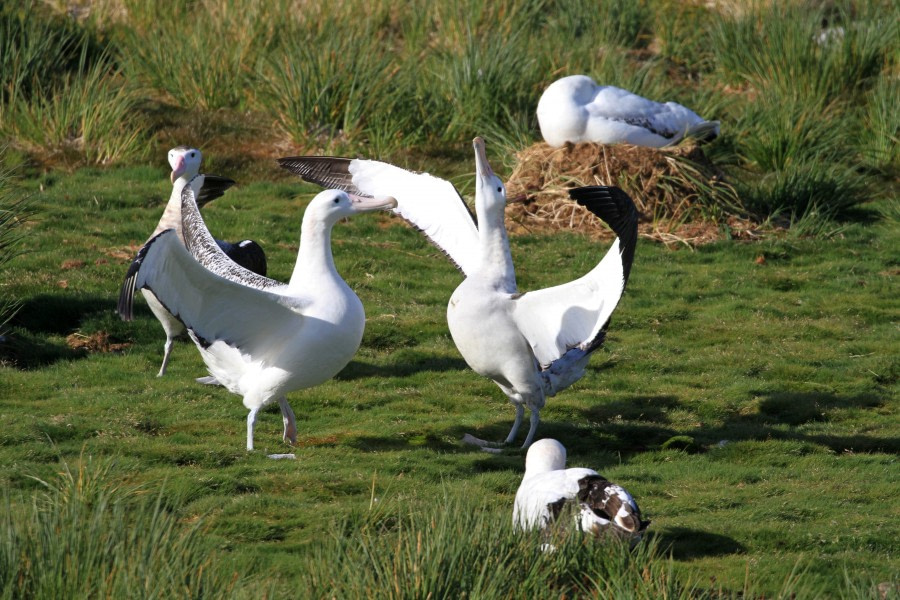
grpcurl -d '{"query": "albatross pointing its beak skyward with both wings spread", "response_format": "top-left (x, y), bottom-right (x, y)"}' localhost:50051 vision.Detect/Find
top-left (278, 138), bottom-right (637, 448)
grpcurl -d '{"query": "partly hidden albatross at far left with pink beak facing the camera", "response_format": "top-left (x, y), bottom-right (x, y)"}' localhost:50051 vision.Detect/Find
top-left (135, 146), bottom-right (266, 383)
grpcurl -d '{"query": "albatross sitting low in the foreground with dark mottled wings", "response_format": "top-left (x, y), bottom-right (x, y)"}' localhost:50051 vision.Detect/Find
top-left (513, 438), bottom-right (650, 541)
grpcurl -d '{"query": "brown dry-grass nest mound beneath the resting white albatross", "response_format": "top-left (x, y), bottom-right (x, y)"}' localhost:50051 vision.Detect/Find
top-left (506, 142), bottom-right (757, 245)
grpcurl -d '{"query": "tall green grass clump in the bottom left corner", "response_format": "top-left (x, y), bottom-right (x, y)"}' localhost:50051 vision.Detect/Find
top-left (0, 457), bottom-right (241, 599)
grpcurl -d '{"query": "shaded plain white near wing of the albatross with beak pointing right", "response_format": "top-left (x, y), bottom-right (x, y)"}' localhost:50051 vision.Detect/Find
top-left (120, 229), bottom-right (304, 356)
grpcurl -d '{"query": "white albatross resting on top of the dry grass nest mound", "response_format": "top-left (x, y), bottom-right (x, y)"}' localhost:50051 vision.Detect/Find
top-left (537, 75), bottom-right (719, 148)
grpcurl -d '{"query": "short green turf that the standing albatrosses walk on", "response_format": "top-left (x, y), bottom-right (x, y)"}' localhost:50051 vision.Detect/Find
top-left (0, 166), bottom-right (900, 598)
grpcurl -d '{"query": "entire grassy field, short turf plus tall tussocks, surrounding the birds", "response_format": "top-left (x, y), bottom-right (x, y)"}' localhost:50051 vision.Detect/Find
top-left (0, 0), bottom-right (900, 600)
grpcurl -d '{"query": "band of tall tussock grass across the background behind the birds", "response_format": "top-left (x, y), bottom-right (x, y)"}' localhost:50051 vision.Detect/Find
top-left (0, 0), bottom-right (900, 230)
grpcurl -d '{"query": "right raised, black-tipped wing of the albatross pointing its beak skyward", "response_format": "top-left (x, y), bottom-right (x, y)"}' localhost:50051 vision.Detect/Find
top-left (513, 186), bottom-right (637, 368)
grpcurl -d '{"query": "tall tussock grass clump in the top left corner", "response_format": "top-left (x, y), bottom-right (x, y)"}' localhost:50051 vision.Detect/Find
top-left (0, 3), bottom-right (147, 165)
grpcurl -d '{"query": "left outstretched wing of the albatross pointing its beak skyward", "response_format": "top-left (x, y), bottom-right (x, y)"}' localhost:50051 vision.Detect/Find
top-left (278, 156), bottom-right (479, 275)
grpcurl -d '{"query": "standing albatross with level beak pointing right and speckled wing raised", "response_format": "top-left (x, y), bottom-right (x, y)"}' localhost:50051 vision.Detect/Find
top-left (118, 175), bottom-right (396, 450)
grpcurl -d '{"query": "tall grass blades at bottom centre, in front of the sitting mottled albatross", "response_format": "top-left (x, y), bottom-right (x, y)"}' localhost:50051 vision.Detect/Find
top-left (304, 495), bottom-right (691, 599)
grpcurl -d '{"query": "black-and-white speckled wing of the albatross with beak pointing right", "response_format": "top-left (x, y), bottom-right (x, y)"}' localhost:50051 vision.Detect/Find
top-left (181, 175), bottom-right (284, 290)
